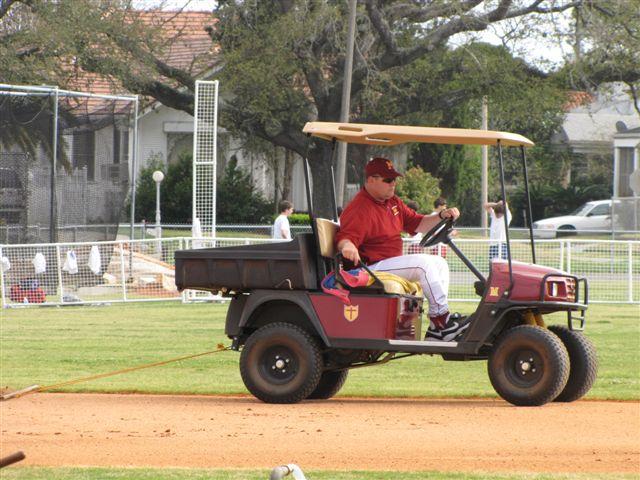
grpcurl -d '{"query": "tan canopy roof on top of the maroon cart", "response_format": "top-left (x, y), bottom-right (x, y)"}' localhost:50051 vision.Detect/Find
top-left (302, 122), bottom-right (533, 147)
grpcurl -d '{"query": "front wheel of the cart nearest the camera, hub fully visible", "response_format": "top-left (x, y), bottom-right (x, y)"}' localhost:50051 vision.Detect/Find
top-left (487, 325), bottom-right (569, 406)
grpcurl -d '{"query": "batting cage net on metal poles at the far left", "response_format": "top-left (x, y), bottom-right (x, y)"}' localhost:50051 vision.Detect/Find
top-left (0, 85), bottom-right (137, 244)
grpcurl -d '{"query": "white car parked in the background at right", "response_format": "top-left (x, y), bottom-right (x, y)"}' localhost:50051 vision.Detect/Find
top-left (533, 200), bottom-right (611, 238)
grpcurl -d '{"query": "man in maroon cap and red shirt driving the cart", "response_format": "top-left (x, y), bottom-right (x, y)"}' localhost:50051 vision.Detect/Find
top-left (336, 157), bottom-right (469, 342)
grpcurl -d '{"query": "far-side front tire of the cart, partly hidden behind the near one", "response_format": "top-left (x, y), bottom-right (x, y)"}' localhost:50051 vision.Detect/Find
top-left (549, 325), bottom-right (598, 402)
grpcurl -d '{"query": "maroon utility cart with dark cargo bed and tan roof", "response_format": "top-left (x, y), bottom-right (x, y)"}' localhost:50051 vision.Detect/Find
top-left (175, 122), bottom-right (597, 405)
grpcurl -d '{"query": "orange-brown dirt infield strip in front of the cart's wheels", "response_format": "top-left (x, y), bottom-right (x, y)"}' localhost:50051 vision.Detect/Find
top-left (0, 394), bottom-right (640, 473)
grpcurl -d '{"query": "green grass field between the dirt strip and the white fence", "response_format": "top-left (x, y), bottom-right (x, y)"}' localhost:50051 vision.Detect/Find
top-left (0, 302), bottom-right (640, 400)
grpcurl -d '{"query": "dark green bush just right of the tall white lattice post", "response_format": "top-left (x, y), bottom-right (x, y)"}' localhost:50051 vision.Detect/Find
top-left (216, 157), bottom-right (274, 224)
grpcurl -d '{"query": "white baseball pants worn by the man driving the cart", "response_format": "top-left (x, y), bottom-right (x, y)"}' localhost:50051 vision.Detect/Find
top-left (369, 253), bottom-right (449, 317)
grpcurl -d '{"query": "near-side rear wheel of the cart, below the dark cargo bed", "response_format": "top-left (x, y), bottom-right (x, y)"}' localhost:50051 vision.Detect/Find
top-left (240, 322), bottom-right (323, 403)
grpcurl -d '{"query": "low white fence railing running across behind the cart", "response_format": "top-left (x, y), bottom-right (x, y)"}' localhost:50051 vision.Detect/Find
top-left (0, 237), bottom-right (640, 307)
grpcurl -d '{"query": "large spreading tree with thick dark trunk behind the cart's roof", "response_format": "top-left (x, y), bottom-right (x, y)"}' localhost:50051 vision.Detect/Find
top-left (0, 0), bottom-right (640, 218)
